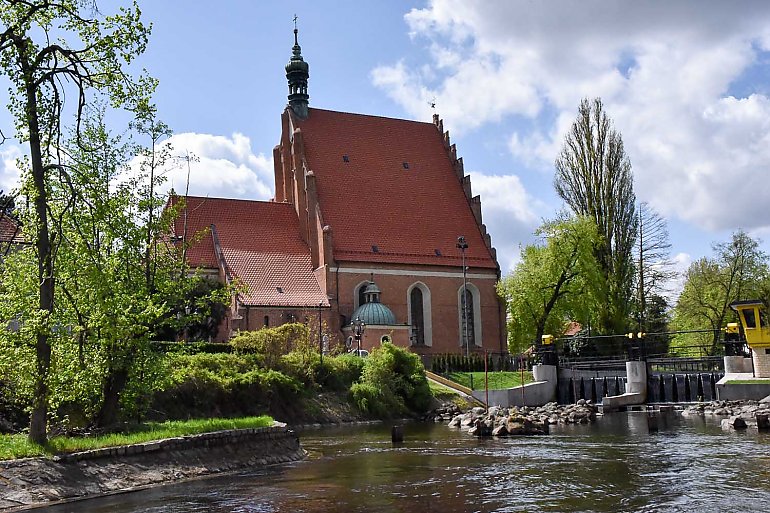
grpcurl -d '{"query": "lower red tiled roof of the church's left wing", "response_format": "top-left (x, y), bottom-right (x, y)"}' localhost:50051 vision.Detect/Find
top-left (174, 196), bottom-right (329, 307)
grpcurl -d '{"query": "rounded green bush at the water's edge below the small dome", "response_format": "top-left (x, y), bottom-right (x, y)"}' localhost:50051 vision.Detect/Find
top-left (351, 343), bottom-right (432, 416)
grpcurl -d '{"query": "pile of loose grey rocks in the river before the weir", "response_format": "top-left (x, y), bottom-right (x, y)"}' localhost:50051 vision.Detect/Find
top-left (427, 399), bottom-right (598, 436)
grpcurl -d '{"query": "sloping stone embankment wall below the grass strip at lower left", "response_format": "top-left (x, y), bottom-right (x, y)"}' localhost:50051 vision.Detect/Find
top-left (0, 423), bottom-right (306, 511)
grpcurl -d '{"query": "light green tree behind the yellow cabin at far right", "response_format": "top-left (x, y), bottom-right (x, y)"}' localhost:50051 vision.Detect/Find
top-left (674, 230), bottom-right (768, 355)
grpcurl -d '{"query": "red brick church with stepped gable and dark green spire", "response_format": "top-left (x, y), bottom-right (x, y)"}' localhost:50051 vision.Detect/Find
top-left (177, 29), bottom-right (507, 356)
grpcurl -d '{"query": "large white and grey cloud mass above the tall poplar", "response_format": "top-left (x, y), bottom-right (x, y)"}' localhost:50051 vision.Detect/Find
top-left (372, 0), bottom-right (770, 237)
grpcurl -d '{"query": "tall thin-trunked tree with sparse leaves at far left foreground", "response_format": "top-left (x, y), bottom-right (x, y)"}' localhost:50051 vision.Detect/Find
top-left (0, 0), bottom-right (154, 443)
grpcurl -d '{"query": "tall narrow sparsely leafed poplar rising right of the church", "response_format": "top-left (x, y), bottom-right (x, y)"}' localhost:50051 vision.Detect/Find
top-left (554, 98), bottom-right (637, 342)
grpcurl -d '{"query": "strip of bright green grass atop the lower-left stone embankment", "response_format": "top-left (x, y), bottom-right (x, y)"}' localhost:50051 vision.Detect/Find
top-left (0, 415), bottom-right (273, 460)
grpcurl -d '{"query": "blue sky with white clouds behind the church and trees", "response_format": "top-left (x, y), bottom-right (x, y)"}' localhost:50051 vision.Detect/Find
top-left (0, 0), bottom-right (770, 288)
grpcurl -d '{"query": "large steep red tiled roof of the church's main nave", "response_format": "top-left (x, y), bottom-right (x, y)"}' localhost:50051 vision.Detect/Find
top-left (294, 109), bottom-right (497, 268)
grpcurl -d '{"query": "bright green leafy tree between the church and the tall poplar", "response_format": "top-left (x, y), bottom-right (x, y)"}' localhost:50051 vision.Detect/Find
top-left (500, 217), bottom-right (598, 353)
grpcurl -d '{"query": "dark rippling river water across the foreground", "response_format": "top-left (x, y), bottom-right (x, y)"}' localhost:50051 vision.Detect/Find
top-left (39, 413), bottom-right (770, 513)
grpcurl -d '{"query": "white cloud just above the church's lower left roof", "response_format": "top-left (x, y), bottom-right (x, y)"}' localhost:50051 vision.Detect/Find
top-left (134, 133), bottom-right (274, 200)
